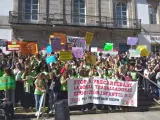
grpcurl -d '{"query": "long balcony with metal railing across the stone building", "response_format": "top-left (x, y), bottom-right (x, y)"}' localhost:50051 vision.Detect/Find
top-left (9, 11), bottom-right (141, 30)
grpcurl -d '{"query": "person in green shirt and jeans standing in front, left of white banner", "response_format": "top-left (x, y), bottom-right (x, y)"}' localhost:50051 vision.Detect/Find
top-left (34, 73), bottom-right (46, 116)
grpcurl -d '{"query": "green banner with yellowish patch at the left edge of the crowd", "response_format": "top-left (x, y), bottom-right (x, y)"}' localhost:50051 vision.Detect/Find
top-left (0, 76), bottom-right (16, 90)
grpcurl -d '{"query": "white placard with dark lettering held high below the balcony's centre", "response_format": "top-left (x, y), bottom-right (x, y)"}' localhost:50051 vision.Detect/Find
top-left (67, 36), bottom-right (86, 49)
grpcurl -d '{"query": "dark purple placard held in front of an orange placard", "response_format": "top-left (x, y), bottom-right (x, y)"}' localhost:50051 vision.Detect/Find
top-left (51, 37), bottom-right (61, 52)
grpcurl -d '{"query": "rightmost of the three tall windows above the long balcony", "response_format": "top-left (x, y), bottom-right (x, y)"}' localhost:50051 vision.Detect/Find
top-left (115, 2), bottom-right (127, 26)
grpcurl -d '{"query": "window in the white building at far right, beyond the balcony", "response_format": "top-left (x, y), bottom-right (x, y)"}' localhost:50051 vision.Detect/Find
top-left (149, 7), bottom-right (157, 24)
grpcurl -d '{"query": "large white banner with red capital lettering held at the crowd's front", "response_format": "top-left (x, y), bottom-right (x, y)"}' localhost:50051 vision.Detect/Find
top-left (68, 77), bottom-right (138, 107)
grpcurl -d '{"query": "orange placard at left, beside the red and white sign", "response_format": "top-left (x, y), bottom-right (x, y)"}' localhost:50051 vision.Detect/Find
top-left (20, 42), bottom-right (38, 55)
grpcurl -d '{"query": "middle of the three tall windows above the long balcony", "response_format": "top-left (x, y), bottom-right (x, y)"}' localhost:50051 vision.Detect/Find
top-left (73, 0), bottom-right (85, 23)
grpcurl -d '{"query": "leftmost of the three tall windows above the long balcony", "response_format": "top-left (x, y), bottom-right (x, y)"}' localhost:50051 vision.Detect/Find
top-left (25, 0), bottom-right (38, 21)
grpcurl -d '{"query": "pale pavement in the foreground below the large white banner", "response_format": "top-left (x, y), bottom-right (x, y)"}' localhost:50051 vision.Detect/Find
top-left (32, 111), bottom-right (160, 120)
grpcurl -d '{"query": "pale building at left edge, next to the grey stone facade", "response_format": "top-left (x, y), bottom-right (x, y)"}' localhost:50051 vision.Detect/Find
top-left (0, 0), bottom-right (13, 52)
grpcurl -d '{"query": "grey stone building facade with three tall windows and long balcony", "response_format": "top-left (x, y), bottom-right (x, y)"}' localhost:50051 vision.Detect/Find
top-left (9, 0), bottom-right (141, 51)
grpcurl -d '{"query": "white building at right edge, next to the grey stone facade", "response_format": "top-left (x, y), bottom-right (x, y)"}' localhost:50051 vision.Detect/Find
top-left (136, 0), bottom-right (160, 53)
